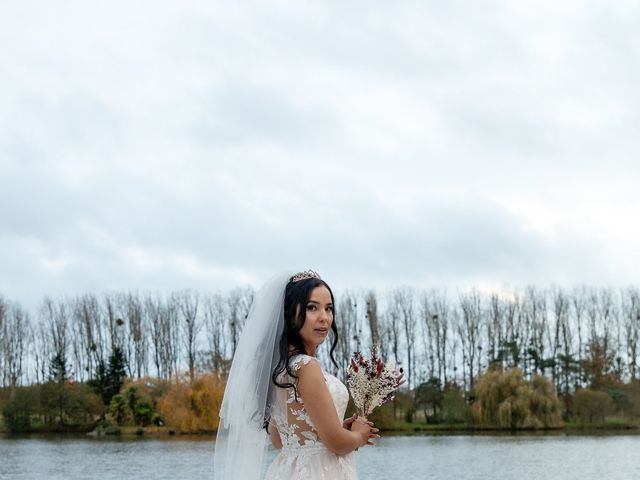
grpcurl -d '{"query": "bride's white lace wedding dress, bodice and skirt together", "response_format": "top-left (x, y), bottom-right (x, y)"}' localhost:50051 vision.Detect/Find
top-left (265, 355), bottom-right (357, 480)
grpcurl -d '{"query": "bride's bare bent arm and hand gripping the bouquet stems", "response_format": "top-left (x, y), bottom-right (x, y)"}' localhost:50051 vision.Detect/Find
top-left (297, 361), bottom-right (372, 454)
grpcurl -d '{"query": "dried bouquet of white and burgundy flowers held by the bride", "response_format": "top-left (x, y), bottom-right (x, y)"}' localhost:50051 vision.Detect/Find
top-left (347, 350), bottom-right (404, 417)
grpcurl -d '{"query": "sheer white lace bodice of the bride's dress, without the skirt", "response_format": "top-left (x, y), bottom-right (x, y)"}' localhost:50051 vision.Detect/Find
top-left (271, 355), bottom-right (349, 448)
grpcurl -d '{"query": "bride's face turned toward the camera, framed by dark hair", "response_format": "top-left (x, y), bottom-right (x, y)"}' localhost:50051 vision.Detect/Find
top-left (300, 285), bottom-right (333, 355)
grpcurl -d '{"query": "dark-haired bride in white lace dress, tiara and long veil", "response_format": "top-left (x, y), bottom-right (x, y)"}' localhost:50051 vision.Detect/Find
top-left (214, 271), bottom-right (378, 480)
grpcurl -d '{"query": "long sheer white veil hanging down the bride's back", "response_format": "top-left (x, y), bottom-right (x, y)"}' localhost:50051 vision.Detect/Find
top-left (213, 272), bottom-right (292, 480)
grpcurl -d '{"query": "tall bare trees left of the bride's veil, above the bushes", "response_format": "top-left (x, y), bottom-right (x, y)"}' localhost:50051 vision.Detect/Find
top-left (0, 288), bottom-right (253, 387)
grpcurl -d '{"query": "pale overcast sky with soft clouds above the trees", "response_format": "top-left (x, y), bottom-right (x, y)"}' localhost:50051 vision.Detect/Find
top-left (0, 0), bottom-right (640, 312)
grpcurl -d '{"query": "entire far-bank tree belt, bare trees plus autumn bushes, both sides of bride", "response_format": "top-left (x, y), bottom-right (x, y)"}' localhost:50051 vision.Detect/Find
top-left (0, 286), bottom-right (640, 431)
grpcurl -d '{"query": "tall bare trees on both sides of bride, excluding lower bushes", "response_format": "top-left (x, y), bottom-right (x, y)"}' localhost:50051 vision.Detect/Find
top-left (0, 286), bottom-right (640, 394)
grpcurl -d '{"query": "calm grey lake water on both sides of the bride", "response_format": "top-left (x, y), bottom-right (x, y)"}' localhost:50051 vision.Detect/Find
top-left (0, 435), bottom-right (640, 480)
